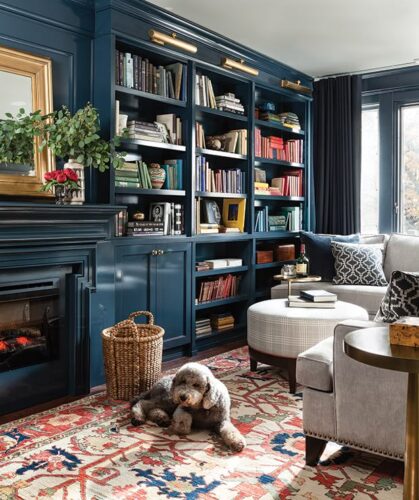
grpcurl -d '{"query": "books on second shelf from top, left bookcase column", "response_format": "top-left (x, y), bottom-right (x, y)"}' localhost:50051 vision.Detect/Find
top-left (127, 113), bottom-right (183, 144)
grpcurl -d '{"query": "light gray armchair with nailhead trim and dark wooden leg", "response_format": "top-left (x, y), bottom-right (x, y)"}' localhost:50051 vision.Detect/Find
top-left (297, 321), bottom-right (407, 465)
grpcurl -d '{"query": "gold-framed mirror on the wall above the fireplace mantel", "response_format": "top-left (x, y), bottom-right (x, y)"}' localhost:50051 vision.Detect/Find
top-left (0, 47), bottom-right (54, 196)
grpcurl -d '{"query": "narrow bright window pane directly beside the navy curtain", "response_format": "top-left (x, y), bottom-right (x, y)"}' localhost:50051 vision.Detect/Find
top-left (361, 107), bottom-right (380, 234)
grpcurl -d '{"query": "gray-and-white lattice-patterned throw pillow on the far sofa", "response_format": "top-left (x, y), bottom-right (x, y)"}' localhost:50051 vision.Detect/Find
top-left (331, 241), bottom-right (387, 286)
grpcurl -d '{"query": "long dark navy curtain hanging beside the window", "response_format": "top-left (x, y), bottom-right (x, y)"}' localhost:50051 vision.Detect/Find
top-left (313, 76), bottom-right (361, 234)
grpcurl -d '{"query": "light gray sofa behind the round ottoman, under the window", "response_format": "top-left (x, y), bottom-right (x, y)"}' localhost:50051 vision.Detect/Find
top-left (271, 233), bottom-right (419, 319)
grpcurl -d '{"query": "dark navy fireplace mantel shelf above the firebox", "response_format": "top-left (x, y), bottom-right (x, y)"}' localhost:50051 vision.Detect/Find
top-left (0, 203), bottom-right (122, 245)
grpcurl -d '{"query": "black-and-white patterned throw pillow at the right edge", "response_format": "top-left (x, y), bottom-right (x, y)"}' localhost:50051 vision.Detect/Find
top-left (375, 271), bottom-right (419, 323)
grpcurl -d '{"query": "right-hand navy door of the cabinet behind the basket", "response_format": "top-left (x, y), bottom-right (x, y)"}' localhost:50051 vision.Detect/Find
top-left (152, 244), bottom-right (192, 348)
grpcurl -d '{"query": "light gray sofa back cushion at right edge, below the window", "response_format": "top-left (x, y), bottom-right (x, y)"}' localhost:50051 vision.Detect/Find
top-left (384, 233), bottom-right (419, 281)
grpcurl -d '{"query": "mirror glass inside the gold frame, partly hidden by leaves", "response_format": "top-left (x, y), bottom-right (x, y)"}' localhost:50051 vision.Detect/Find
top-left (0, 71), bottom-right (35, 176)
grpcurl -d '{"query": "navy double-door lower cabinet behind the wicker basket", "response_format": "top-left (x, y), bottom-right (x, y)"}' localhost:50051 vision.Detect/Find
top-left (115, 240), bottom-right (191, 351)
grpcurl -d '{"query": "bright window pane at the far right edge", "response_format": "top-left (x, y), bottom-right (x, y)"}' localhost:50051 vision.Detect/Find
top-left (398, 104), bottom-right (419, 235)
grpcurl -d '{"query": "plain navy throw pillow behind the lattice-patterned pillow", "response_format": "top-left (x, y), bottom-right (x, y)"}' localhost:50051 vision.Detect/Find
top-left (301, 231), bottom-right (359, 281)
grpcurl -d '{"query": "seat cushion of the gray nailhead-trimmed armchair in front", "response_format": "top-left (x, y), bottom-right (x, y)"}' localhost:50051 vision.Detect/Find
top-left (297, 336), bottom-right (333, 392)
